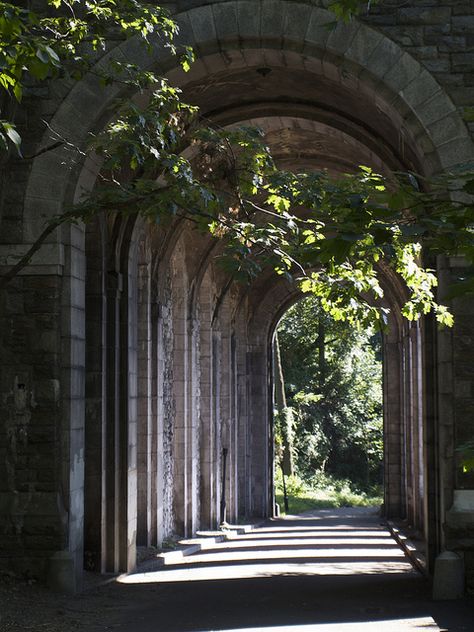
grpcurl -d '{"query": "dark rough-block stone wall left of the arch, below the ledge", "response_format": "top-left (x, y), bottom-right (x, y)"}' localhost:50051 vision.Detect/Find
top-left (0, 276), bottom-right (67, 574)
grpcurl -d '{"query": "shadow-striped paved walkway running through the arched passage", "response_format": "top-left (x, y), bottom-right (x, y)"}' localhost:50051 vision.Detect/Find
top-left (91, 509), bottom-right (474, 632)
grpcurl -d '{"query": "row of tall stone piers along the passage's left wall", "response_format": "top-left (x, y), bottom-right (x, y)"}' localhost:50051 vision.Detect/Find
top-left (84, 217), bottom-right (262, 572)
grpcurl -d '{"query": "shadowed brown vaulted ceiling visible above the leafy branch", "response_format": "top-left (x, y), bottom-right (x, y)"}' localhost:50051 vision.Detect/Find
top-left (182, 66), bottom-right (421, 173)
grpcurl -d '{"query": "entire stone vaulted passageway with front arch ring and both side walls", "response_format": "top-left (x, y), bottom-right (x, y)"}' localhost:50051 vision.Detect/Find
top-left (1, 0), bottom-right (474, 590)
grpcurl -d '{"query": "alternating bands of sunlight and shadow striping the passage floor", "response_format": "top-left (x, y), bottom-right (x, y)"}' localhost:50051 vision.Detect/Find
top-left (119, 520), bottom-right (415, 584)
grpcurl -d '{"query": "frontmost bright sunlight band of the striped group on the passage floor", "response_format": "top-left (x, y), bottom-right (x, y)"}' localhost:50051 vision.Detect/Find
top-left (117, 560), bottom-right (415, 584)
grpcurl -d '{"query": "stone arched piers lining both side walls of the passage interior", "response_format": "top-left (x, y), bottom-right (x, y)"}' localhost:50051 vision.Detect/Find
top-left (78, 207), bottom-right (434, 572)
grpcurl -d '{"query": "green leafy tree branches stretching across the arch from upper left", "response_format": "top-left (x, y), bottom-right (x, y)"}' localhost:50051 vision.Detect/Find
top-left (0, 0), bottom-right (474, 326)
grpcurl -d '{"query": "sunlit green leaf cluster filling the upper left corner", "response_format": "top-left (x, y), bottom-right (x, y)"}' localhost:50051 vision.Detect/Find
top-left (0, 0), bottom-right (181, 150)
